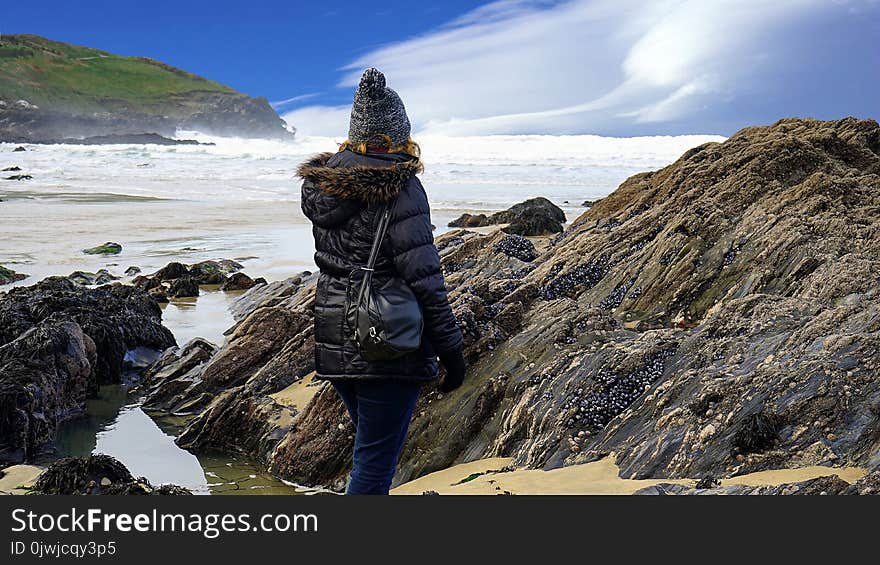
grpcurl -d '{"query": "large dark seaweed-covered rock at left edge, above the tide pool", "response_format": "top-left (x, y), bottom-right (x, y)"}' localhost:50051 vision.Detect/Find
top-left (0, 277), bottom-right (174, 463)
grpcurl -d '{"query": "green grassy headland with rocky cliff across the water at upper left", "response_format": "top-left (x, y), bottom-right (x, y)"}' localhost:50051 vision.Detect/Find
top-left (0, 35), bottom-right (294, 139)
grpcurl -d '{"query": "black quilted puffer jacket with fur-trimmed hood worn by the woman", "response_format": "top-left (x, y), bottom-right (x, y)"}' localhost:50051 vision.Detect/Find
top-left (298, 151), bottom-right (462, 381)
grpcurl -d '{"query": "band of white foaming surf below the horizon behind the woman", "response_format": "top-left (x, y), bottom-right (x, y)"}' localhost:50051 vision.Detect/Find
top-left (0, 131), bottom-right (723, 203)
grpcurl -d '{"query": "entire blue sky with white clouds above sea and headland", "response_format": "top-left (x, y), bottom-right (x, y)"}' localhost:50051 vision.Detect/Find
top-left (0, 0), bottom-right (880, 135)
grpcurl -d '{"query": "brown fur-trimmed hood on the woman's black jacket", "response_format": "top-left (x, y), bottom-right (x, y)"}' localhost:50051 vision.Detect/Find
top-left (296, 153), bottom-right (422, 204)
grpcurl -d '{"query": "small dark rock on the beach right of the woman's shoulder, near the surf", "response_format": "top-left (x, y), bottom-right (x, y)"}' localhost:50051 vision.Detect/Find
top-left (449, 197), bottom-right (566, 236)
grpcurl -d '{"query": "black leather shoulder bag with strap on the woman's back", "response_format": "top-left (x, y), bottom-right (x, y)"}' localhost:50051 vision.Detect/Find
top-left (346, 205), bottom-right (423, 361)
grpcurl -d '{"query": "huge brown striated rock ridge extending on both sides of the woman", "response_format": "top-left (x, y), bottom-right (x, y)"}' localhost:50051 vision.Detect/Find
top-left (141, 118), bottom-right (880, 489)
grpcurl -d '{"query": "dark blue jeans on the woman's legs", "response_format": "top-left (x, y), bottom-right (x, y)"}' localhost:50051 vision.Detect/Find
top-left (332, 380), bottom-right (421, 494)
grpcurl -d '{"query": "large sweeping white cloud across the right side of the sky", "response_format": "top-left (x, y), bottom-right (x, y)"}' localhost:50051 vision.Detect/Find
top-left (285, 0), bottom-right (877, 136)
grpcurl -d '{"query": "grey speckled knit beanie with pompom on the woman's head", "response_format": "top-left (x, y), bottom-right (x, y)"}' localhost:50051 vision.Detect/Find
top-left (348, 68), bottom-right (410, 145)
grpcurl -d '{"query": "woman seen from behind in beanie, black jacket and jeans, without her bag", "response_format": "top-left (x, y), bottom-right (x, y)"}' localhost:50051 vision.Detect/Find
top-left (297, 68), bottom-right (465, 494)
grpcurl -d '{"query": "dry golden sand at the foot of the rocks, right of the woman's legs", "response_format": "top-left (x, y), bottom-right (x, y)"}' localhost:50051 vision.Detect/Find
top-left (391, 457), bottom-right (866, 495)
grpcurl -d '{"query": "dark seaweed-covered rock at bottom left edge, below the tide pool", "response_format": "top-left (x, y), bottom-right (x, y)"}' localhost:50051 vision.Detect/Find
top-left (31, 453), bottom-right (192, 495)
